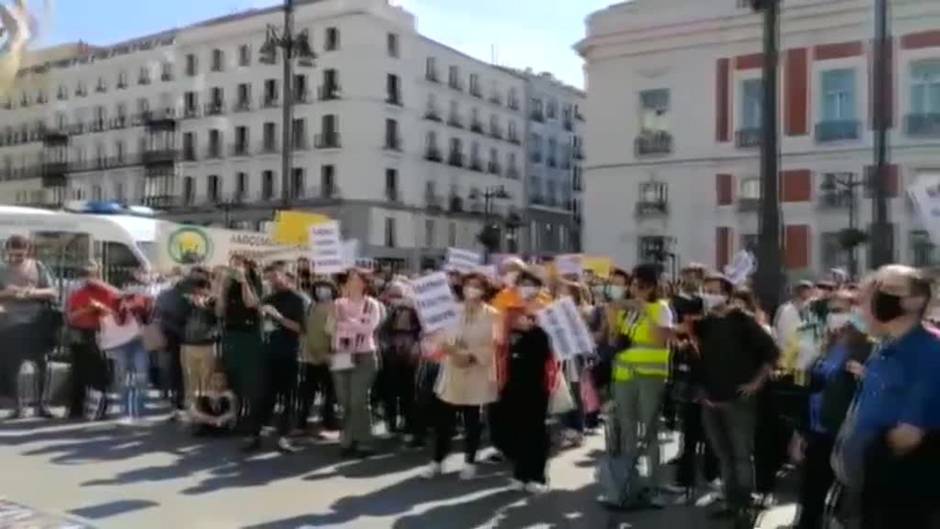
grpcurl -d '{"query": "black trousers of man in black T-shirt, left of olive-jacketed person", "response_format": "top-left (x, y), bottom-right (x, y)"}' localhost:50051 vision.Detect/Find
top-left (252, 350), bottom-right (297, 436)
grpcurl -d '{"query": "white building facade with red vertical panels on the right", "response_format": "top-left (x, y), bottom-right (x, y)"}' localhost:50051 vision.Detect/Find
top-left (578, 0), bottom-right (940, 277)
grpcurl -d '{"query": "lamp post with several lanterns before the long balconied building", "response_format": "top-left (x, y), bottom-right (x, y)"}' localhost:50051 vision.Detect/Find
top-left (258, 0), bottom-right (316, 209)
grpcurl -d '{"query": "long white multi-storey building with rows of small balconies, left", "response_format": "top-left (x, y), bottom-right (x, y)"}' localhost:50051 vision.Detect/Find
top-left (0, 0), bottom-right (584, 268)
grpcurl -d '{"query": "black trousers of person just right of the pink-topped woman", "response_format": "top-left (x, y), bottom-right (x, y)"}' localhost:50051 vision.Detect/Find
top-left (379, 345), bottom-right (418, 434)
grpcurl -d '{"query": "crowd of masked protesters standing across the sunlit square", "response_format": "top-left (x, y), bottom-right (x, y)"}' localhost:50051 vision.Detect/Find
top-left (0, 236), bottom-right (940, 529)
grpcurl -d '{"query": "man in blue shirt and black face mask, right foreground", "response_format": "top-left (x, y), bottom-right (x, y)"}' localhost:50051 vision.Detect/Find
top-left (832, 265), bottom-right (940, 529)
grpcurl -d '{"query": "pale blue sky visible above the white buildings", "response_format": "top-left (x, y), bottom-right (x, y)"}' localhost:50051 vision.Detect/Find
top-left (29, 0), bottom-right (617, 87)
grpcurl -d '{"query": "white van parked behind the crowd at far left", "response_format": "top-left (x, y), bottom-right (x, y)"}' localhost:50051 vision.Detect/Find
top-left (0, 206), bottom-right (156, 284)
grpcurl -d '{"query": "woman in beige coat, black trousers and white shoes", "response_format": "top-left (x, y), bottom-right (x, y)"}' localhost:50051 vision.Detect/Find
top-left (424, 274), bottom-right (499, 479)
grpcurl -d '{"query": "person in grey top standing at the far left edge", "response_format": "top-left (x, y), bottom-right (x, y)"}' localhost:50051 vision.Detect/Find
top-left (0, 235), bottom-right (62, 419)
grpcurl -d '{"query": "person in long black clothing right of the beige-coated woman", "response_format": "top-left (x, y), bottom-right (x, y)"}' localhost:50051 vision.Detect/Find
top-left (500, 272), bottom-right (558, 494)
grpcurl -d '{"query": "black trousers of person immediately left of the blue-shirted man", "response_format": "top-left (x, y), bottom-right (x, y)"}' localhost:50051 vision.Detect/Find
top-left (795, 432), bottom-right (835, 529)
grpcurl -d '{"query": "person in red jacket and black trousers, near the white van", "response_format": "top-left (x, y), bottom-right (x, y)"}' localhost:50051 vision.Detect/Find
top-left (66, 261), bottom-right (120, 420)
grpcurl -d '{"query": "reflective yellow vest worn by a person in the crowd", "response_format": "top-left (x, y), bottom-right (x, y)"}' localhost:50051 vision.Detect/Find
top-left (613, 300), bottom-right (670, 382)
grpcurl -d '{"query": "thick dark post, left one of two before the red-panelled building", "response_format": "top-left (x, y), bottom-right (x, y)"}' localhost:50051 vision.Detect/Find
top-left (751, 0), bottom-right (784, 313)
